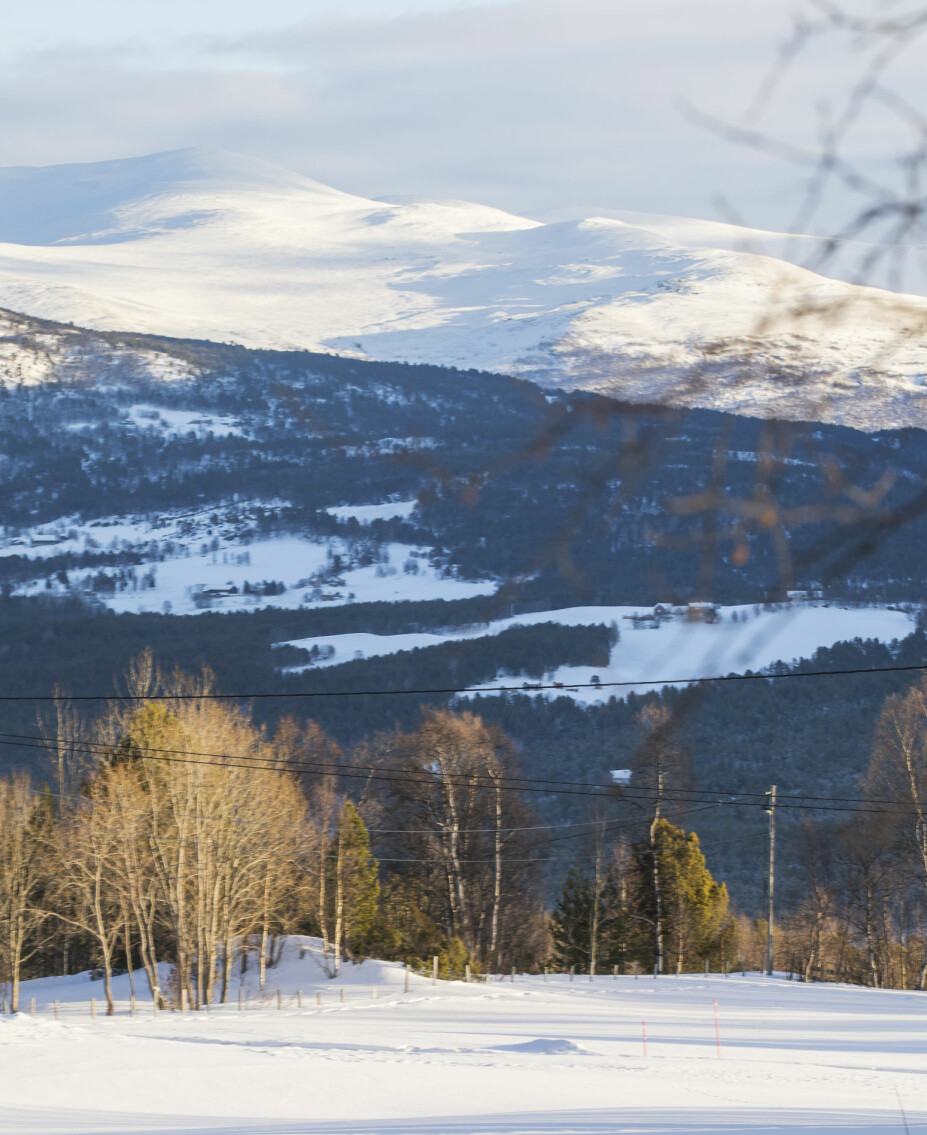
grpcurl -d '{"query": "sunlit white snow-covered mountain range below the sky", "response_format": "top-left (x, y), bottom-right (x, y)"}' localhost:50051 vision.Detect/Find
top-left (0, 143), bottom-right (927, 428)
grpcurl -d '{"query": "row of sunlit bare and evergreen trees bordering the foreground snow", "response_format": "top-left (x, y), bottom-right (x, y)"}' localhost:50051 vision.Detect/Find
top-left (9, 653), bottom-right (927, 1011)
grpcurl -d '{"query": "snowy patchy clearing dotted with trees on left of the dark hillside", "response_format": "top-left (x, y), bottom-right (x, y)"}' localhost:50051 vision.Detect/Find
top-left (0, 501), bottom-right (498, 615)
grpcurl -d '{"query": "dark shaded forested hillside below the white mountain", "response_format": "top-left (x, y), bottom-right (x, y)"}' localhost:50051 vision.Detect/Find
top-left (0, 310), bottom-right (927, 909)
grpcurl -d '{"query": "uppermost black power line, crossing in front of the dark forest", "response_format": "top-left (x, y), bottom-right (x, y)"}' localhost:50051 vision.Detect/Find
top-left (0, 663), bottom-right (927, 703)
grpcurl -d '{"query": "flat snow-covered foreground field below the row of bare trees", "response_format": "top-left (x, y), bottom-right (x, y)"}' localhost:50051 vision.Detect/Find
top-left (0, 940), bottom-right (927, 1135)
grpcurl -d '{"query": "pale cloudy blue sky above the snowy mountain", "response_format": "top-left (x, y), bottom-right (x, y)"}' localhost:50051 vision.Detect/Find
top-left (0, 0), bottom-right (927, 227)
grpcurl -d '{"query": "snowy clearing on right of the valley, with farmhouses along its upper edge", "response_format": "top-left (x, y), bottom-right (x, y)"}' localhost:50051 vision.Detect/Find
top-left (276, 603), bottom-right (915, 704)
